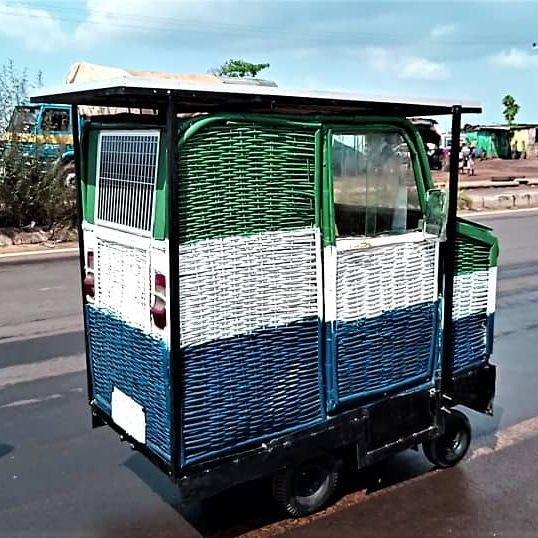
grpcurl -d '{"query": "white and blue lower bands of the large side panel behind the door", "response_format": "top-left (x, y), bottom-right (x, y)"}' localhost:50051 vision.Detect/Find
top-left (180, 229), bottom-right (321, 463)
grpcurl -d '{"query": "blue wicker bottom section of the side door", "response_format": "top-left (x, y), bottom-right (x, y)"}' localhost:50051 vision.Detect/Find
top-left (336, 303), bottom-right (437, 400)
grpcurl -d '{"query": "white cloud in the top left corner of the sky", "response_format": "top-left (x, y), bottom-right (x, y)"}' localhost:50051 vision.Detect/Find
top-left (0, 1), bottom-right (68, 52)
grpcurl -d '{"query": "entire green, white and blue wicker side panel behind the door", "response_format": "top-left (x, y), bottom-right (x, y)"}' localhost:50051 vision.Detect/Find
top-left (178, 122), bottom-right (322, 464)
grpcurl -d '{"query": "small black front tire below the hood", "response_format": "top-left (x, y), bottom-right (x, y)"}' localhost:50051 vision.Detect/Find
top-left (422, 410), bottom-right (471, 469)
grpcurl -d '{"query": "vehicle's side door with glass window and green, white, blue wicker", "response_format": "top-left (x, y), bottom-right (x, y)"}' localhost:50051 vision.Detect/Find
top-left (323, 125), bottom-right (439, 411)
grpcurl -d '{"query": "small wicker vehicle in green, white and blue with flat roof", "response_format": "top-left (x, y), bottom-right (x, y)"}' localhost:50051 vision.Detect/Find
top-left (31, 79), bottom-right (498, 516)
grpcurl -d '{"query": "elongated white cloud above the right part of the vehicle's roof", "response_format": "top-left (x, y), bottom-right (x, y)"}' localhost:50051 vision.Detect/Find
top-left (364, 47), bottom-right (450, 80)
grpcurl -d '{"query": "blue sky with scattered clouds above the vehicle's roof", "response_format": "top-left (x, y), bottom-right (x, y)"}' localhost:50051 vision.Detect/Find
top-left (0, 0), bottom-right (538, 127)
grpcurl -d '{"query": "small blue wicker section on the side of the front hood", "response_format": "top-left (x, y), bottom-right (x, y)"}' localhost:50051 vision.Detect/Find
top-left (451, 312), bottom-right (486, 373)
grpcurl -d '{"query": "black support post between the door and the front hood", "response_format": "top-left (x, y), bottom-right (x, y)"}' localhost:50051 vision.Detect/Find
top-left (441, 106), bottom-right (461, 393)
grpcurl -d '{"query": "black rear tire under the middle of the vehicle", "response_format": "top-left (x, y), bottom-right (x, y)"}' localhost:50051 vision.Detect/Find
top-left (273, 456), bottom-right (341, 517)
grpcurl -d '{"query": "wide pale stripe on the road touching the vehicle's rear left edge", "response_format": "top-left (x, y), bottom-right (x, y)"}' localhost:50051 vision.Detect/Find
top-left (0, 355), bottom-right (86, 389)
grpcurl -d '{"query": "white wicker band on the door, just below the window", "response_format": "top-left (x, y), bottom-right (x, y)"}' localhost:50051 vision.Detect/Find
top-left (336, 240), bottom-right (438, 321)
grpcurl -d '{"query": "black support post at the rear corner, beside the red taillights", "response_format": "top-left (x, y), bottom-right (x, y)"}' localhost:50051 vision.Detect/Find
top-left (166, 97), bottom-right (181, 478)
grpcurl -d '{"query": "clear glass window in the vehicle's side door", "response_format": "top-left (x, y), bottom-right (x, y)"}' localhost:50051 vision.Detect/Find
top-left (332, 132), bottom-right (422, 237)
